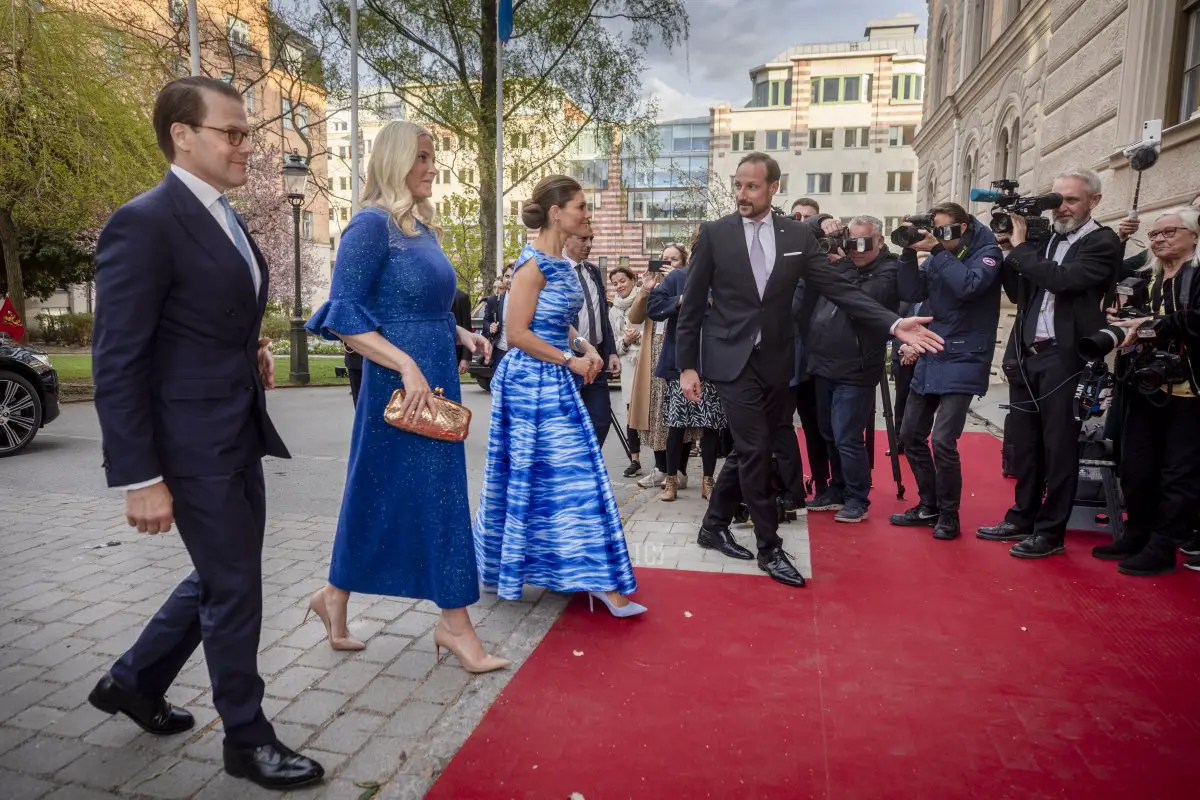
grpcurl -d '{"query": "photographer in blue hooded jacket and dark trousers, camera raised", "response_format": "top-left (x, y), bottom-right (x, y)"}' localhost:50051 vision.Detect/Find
top-left (890, 203), bottom-right (1002, 539)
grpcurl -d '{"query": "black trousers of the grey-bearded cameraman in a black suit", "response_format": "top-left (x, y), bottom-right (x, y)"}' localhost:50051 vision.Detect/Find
top-left (1004, 349), bottom-right (1080, 542)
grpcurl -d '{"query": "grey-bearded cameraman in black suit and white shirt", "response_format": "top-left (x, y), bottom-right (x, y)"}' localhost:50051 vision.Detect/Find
top-left (977, 169), bottom-right (1122, 559)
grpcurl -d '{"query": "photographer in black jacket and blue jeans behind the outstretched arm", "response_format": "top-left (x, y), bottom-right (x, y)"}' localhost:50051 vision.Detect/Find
top-left (804, 216), bottom-right (900, 523)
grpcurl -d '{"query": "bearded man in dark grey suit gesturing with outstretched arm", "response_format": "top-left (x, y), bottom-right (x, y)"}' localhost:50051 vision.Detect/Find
top-left (676, 152), bottom-right (941, 587)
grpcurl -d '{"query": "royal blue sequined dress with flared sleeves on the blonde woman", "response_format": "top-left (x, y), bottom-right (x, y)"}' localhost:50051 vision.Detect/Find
top-left (307, 207), bottom-right (479, 608)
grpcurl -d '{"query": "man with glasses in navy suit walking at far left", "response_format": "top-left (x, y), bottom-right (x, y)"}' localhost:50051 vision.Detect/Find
top-left (89, 77), bottom-right (324, 789)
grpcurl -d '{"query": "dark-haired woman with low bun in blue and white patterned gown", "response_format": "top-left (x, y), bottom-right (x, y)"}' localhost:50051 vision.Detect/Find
top-left (474, 175), bottom-right (646, 616)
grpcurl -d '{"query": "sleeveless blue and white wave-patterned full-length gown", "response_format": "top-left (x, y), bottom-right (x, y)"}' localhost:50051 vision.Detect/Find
top-left (474, 245), bottom-right (637, 600)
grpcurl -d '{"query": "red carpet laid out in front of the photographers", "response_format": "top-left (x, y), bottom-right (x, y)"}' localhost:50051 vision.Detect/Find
top-left (427, 434), bottom-right (1200, 800)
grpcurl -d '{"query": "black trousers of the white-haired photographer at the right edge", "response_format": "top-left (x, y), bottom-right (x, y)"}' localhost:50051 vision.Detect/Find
top-left (1121, 390), bottom-right (1200, 545)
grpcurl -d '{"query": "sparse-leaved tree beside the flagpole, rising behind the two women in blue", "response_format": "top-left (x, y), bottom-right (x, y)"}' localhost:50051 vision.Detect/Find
top-left (320, 0), bottom-right (688, 284)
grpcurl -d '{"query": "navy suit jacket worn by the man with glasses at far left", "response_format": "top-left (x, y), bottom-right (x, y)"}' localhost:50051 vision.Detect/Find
top-left (92, 173), bottom-right (289, 486)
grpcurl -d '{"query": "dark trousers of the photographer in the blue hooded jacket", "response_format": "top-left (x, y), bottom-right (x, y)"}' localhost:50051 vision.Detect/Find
top-left (900, 392), bottom-right (972, 512)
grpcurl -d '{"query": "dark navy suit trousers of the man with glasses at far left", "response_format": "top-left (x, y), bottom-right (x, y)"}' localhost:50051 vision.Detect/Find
top-left (112, 462), bottom-right (275, 747)
